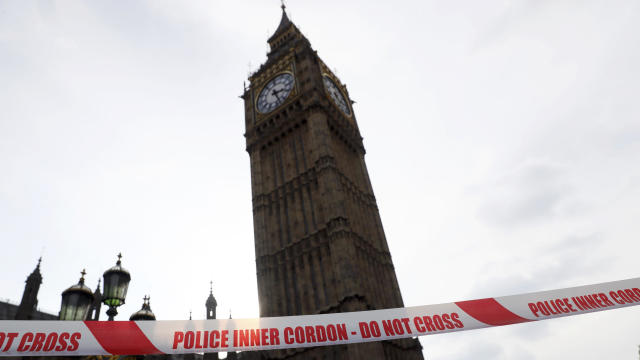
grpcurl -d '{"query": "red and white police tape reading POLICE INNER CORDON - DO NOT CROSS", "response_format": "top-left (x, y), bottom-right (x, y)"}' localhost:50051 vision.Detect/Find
top-left (0, 278), bottom-right (640, 356)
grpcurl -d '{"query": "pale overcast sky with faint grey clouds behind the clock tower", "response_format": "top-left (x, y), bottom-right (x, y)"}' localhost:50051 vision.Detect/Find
top-left (0, 0), bottom-right (640, 360)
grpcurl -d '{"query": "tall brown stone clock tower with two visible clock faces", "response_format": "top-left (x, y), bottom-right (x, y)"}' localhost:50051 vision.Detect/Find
top-left (242, 5), bottom-right (423, 359)
